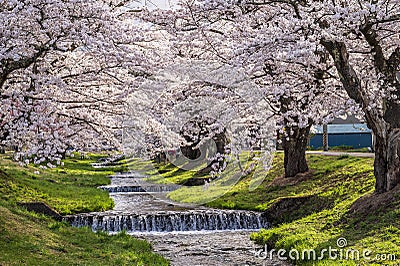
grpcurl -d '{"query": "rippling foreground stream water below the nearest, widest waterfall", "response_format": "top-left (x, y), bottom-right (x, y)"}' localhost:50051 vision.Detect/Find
top-left (133, 231), bottom-right (289, 266)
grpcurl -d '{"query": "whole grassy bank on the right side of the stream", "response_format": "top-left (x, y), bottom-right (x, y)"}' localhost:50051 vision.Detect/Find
top-left (147, 154), bottom-right (400, 265)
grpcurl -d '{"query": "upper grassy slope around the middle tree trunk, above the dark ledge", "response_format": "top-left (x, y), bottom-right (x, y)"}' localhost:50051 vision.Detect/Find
top-left (203, 154), bottom-right (374, 211)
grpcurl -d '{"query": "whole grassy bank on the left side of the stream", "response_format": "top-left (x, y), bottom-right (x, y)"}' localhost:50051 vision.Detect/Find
top-left (0, 155), bottom-right (169, 266)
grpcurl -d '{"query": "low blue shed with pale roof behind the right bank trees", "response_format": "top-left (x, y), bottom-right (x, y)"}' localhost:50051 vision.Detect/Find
top-left (310, 124), bottom-right (372, 149)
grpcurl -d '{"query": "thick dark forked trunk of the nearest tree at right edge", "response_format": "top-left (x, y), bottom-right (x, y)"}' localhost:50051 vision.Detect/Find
top-left (321, 38), bottom-right (400, 193)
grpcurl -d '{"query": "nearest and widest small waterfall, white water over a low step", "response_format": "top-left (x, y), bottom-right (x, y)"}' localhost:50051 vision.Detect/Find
top-left (64, 210), bottom-right (268, 232)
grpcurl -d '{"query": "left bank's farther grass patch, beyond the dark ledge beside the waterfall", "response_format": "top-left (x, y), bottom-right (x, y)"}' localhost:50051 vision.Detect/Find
top-left (0, 154), bottom-right (114, 215)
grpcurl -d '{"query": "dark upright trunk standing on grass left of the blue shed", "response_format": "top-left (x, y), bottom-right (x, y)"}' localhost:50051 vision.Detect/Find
top-left (282, 127), bottom-right (310, 177)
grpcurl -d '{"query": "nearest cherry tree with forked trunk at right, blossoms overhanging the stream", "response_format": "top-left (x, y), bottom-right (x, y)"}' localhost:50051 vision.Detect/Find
top-left (148, 0), bottom-right (400, 193)
